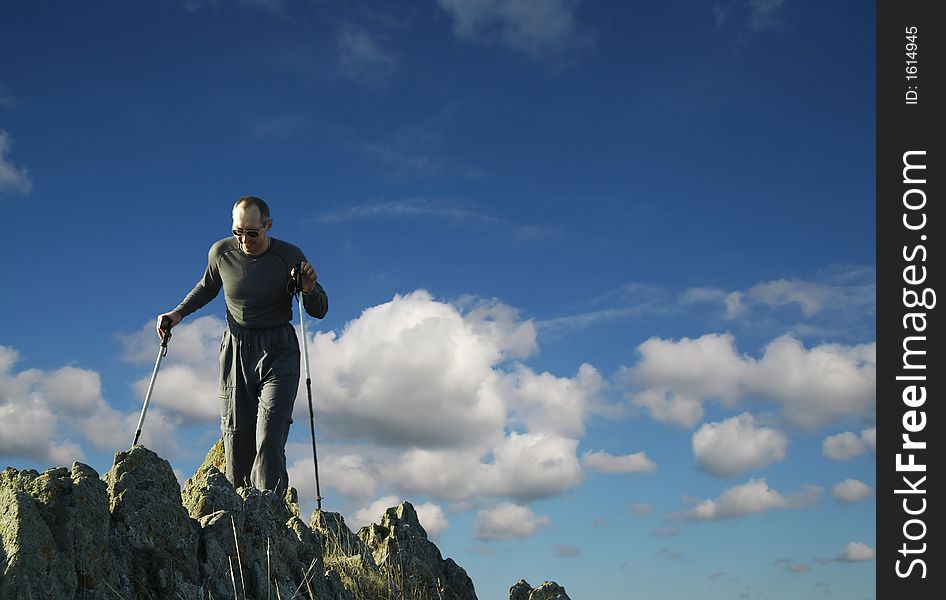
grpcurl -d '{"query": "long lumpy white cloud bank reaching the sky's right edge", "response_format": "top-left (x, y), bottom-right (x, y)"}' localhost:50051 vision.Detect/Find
top-left (618, 334), bottom-right (876, 429)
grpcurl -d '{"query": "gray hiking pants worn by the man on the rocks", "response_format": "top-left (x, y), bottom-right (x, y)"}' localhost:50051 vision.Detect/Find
top-left (220, 323), bottom-right (299, 496)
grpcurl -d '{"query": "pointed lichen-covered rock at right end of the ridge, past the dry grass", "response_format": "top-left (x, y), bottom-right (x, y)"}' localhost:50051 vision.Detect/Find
top-left (358, 502), bottom-right (484, 600)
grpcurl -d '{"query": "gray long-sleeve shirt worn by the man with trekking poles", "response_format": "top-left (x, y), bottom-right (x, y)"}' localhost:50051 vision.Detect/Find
top-left (175, 237), bottom-right (328, 329)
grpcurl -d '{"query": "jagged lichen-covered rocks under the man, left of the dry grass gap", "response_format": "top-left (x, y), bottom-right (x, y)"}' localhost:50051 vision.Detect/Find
top-left (0, 446), bottom-right (354, 600)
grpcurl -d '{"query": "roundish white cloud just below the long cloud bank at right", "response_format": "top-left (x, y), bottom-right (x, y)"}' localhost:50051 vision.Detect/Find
top-left (692, 413), bottom-right (788, 477)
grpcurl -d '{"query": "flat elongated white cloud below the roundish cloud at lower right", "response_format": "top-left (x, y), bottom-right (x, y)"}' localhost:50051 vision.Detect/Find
top-left (669, 479), bottom-right (821, 521)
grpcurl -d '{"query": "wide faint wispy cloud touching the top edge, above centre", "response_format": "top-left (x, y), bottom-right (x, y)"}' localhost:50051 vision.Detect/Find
top-left (439, 0), bottom-right (592, 58)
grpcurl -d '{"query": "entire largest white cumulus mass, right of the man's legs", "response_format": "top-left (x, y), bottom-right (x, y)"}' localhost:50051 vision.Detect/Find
top-left (276, 290), bottom-right (608, 503)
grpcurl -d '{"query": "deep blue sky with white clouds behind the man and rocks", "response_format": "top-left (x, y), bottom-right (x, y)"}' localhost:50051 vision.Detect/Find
top-left (0, 0), bottom-right (876, 600)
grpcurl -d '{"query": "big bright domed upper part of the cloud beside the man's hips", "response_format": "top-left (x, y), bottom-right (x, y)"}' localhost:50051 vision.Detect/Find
top-left (306, 291), bottom-right (506, 447)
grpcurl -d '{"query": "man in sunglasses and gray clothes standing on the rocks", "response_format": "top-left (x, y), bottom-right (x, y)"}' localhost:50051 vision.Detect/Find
top-left (157, 196), bottom-right (328, 496)
